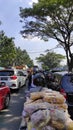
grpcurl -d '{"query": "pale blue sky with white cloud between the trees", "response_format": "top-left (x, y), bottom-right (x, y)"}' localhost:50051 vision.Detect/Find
top-left (0, 0), bottom-right (65, 64)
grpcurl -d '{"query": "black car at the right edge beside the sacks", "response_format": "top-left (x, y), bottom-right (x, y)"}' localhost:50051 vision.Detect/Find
top-left (54, 72), bottom-right (73, 119)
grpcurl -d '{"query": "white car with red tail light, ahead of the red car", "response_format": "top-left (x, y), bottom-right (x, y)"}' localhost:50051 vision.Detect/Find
top-left (0, 68), bottom-right (26, 89)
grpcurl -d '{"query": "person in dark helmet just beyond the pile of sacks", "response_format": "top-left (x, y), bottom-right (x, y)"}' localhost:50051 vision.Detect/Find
top-left (25, 73), bottom-right (46, 101)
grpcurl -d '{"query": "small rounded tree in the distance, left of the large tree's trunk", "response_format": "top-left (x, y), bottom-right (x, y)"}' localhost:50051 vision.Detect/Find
top-left (36, 52), bottom-right (65, 69)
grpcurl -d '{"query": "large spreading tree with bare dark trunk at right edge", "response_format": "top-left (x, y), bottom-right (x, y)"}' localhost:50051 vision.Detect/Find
top-left (20, 0), bottom-right (73, 70)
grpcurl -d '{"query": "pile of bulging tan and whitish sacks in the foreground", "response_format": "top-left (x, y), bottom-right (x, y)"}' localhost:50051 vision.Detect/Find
top-left (23, 88), bottom-right (73, 130)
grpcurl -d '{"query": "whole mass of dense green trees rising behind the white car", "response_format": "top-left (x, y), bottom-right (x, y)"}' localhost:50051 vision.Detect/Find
top-left (0, 31), bottom-right (33, 67)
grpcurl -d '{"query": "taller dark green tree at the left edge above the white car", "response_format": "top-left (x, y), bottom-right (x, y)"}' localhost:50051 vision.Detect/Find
top-left (0, 31), bottom-right (16, 67)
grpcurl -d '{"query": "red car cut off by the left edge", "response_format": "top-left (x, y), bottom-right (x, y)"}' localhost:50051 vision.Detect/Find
top-left (0, 82), bottom-right (10, 110)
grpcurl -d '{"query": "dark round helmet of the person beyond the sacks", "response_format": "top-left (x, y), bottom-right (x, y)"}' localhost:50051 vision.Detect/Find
top-left (33, 73), bottom-right (45, 87)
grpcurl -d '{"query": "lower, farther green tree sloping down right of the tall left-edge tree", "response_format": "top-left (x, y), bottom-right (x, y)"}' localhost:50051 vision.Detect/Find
top-left (15, 47), bottom-right (33, 66)
